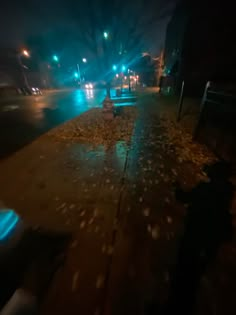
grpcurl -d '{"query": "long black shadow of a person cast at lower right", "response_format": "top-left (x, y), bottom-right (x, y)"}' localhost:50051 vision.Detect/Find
top-left (164, 161), bottom-right (234, 315)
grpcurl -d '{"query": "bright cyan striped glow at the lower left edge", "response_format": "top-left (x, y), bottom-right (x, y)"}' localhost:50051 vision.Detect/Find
top-left (0, 209), bottom-right (20, 241)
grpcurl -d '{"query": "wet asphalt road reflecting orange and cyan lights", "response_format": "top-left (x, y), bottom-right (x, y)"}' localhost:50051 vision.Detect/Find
top-left (0, 90), bottom-right (105, 158)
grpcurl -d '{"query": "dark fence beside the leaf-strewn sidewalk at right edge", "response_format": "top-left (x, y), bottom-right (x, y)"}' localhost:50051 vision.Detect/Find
top-left (194, 82), bottom-right (236, 162)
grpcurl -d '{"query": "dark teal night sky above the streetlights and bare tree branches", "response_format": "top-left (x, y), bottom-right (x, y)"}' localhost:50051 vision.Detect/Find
top-left (0, 0), bottom-right (176, 54)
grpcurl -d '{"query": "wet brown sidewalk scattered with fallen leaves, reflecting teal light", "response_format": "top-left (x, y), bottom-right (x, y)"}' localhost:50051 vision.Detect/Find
top-left (0, 95), bottom-right (236, 315)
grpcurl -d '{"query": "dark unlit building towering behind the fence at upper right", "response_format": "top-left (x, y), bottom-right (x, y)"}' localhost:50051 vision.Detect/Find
top-left (164, 0), bottom-right (236, 95)
